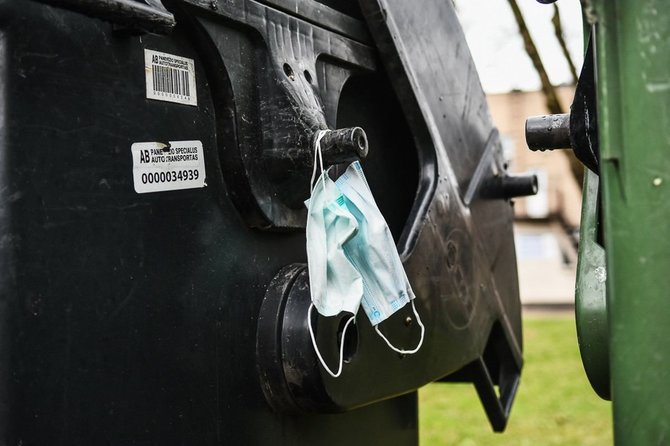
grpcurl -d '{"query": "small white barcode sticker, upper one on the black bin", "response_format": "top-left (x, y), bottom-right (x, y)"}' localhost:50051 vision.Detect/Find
top-left (144, 49), bottom-right (198, 105)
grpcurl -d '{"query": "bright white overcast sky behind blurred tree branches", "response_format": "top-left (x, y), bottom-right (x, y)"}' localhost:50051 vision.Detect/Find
top-left (455, 0), bottom-right (583, 93)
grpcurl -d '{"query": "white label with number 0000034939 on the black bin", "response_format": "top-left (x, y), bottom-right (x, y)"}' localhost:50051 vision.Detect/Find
top-left (130, 141), bottom-right (205, 194)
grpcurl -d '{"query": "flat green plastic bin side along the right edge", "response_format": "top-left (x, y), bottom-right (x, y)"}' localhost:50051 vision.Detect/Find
top-left (594, 0), bottom-right (670, 445)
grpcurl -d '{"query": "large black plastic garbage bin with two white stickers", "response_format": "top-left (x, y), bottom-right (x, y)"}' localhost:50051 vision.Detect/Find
top-left (0, 0), bottom-right (521, 445)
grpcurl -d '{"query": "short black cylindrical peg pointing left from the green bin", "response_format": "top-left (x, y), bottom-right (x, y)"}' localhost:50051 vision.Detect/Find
top-left (526, 113), bottom-right (571, 151)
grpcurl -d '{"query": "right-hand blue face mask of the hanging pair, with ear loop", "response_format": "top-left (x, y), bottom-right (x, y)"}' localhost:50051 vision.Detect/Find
top-left (335, 161), bottom-right (425, 354)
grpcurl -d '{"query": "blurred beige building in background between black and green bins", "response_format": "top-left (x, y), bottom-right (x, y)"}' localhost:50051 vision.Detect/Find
top-left (487, 86), bottom-right (581, 307)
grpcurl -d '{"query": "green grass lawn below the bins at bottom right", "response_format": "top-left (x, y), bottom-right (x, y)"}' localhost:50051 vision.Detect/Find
top-left (419, 316), bottom-right (612, 446)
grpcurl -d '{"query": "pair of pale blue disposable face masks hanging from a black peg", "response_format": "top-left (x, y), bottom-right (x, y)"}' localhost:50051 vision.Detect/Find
top-left (306, 131), bottom-right (425, 378)
